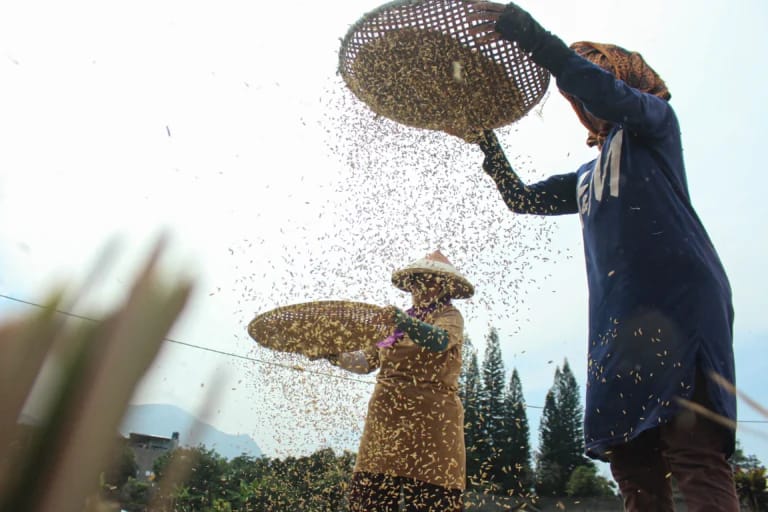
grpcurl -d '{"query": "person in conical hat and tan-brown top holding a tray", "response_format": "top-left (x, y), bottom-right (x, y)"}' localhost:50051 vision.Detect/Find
top-left (320, 251), bottom-right (474, 512)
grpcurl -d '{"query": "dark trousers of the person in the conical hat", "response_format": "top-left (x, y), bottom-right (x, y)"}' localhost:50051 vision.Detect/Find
top-left (349, 471), bottom-right (464, 512)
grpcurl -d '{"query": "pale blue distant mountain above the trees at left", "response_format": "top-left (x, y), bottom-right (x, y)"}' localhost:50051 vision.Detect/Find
top-left (120, 404), bottom-right (261, 459)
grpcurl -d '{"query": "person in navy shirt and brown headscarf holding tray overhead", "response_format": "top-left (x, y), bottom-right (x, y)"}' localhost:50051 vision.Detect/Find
top-left (471, 2), bottom-right (739, 512)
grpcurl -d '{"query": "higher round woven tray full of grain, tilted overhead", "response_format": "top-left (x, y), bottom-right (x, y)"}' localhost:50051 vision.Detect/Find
top-left (339, 0), bottom-right (549, 135)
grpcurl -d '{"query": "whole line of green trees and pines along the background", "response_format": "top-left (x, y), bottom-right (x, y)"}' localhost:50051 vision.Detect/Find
top-left (94, 328), bottom-right (768, 512)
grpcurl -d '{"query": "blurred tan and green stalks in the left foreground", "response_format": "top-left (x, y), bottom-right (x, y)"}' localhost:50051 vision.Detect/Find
top-left (0, 243), bottom-right (191, 512)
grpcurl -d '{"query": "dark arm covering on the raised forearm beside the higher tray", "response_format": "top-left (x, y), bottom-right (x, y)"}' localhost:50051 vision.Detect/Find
top-left (496, 3), bottom-right (572, 75)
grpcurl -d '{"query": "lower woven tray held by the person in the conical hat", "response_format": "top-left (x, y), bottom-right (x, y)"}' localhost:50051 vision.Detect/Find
top-left (248, 301), bottom-right (393, 357)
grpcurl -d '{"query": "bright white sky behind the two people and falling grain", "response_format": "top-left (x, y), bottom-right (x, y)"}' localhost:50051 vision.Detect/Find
top-left (0, 0), bottom-right (768, 476)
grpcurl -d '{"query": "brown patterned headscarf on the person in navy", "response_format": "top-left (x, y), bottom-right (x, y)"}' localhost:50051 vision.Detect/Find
top-left (563, 41), bottom-right (672, 146)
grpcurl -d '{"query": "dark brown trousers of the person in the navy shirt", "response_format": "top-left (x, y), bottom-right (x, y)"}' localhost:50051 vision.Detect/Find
top-left (609, 379), bottom-right (739, 512)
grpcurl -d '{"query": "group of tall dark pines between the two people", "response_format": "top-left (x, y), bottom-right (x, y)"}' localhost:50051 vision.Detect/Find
top-left (459, 328), bottom-right (616, 498)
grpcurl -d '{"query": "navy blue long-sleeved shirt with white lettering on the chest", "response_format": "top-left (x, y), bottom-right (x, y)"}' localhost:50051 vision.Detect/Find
top-left (483, 53), bottom-right (736, 458)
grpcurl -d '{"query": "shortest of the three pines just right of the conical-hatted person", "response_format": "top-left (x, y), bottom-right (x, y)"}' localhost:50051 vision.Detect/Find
top-left (500, 369), bottom-right (533, 496)
